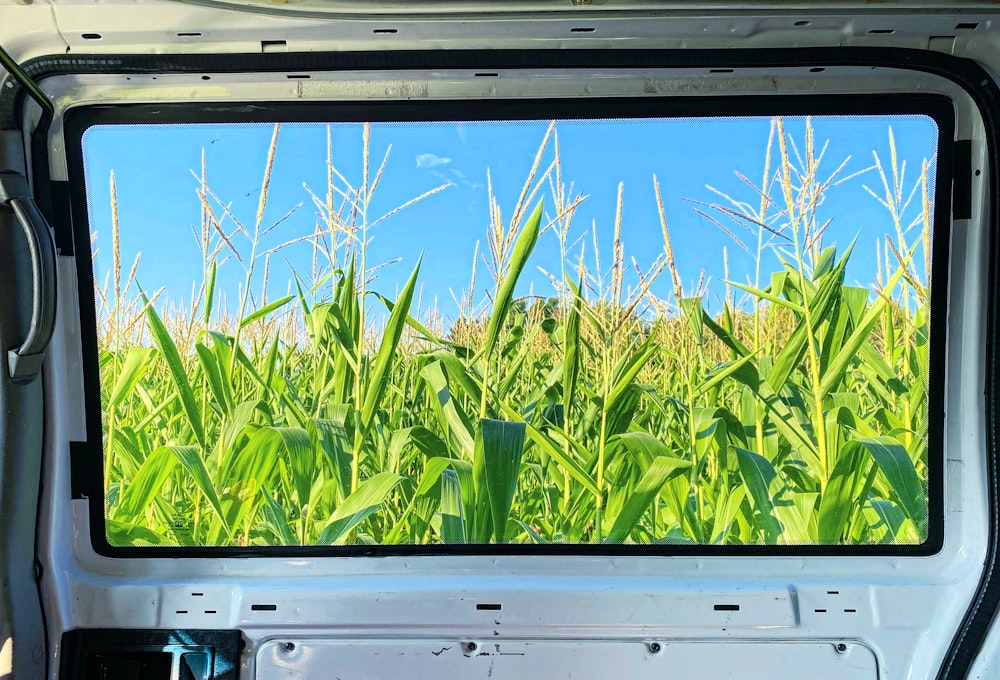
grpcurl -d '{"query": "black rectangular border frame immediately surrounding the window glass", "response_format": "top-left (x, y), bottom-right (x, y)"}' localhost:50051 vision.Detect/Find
top-left (64, 94), bottom-right (962, 558)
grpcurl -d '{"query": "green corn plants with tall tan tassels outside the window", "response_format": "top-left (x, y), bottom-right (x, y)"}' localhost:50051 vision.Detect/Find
top-left (91, 118), bottom-right (932, 546)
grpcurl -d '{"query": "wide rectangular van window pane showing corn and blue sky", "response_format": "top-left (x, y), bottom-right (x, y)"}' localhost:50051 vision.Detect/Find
top-left (70, 98), bottom-right (950, 553)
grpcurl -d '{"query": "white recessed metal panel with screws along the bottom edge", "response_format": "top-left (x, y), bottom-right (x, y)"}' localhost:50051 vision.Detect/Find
top-left (256, 639), bottom-right (878, 680)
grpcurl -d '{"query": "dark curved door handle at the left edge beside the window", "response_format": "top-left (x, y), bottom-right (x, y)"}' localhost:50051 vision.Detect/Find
top-left (0, 172), bottom-right (56, 380)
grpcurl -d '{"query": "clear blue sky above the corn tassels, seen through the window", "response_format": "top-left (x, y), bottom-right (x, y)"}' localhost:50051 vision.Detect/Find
top-left (84, 116), bottom-right (937, 326)
